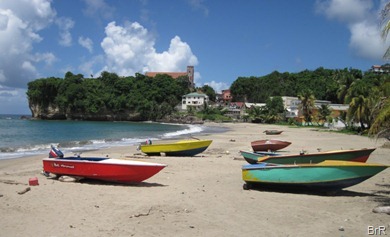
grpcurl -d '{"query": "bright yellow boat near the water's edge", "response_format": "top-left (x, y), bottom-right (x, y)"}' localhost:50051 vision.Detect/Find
top-left (140, 140), bottom-right (212, 156)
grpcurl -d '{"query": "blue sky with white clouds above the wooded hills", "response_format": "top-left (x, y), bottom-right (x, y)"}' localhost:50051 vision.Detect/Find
top-left (0, 0), bottom-right (389, 114)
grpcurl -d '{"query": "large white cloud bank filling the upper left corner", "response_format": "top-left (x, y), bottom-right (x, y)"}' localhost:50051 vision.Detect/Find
top-left (0, 0), bottom-right (56, 88)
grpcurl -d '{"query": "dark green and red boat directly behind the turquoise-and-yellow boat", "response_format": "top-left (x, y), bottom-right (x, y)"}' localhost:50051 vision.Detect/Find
top-left (240, 148), bottom-right (376, 164)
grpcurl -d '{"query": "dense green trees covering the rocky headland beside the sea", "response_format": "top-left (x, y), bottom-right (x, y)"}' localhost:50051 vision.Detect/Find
top-left (27, 72), bottom-right (190, 120)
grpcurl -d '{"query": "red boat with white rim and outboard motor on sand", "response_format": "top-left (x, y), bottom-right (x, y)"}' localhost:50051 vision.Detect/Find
top-left (43, 146), bottom-right (166, 183)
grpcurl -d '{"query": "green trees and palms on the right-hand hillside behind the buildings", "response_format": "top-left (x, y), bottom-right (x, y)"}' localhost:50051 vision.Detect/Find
top-left (230, 65), bottom-right (390, 137)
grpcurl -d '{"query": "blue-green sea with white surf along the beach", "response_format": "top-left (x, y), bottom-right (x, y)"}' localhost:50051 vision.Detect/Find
top-left (0, 114), bottom-right (226, 160)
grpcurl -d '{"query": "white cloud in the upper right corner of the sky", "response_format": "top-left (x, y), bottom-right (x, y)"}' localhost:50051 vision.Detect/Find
top-left (316, 0), bottom-right (388, 60)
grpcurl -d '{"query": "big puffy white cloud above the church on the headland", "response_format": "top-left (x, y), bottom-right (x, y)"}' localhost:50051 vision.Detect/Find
top-left (101, 22), bottom-right (198, 76)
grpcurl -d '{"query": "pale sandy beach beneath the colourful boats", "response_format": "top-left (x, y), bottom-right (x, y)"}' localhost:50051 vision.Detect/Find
top-left (0, 123), bottom-right (390, 237)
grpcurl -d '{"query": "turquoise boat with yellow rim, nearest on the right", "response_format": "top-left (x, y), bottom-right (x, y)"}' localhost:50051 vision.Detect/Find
top-left (242, 160), bottom-right (388, 191)
